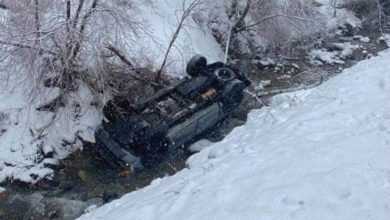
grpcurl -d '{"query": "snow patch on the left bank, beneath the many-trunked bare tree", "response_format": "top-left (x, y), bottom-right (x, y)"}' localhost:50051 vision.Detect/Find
top-left (0, 73), bottom-right (101, 183)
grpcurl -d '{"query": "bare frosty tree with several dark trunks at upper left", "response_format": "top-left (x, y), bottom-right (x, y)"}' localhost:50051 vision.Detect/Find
top-left (0, 0), bottom-right (145, 96)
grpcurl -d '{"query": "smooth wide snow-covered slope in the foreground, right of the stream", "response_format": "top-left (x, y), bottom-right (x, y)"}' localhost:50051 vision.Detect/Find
top-left (80, 51), bottom-right (390, 220)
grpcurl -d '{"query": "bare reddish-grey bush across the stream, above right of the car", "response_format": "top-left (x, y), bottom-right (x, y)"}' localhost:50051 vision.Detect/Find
top-left (222, 0), bottom-right (321, 55)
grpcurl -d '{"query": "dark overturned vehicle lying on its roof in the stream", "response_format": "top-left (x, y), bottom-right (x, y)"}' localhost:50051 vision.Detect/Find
top-left (94, 55), bottom-right (250, 169)
